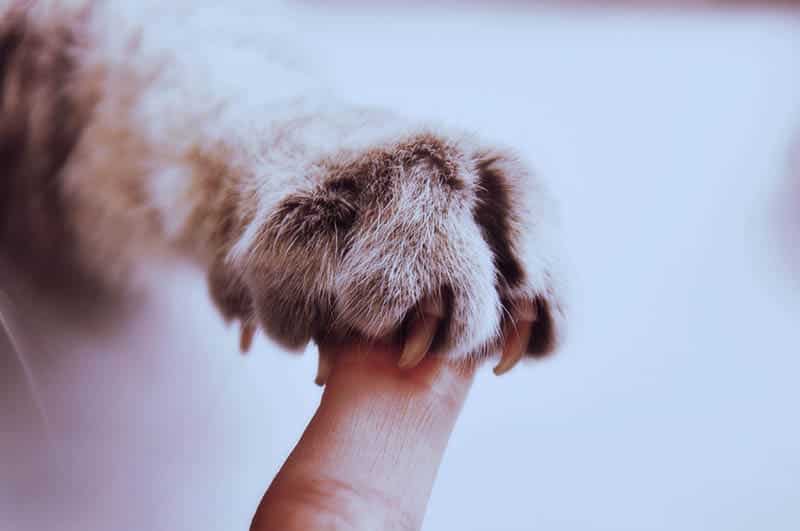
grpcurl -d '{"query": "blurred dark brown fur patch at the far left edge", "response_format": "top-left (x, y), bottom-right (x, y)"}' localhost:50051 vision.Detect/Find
top-left (0, 5), bottom-right (96, 283)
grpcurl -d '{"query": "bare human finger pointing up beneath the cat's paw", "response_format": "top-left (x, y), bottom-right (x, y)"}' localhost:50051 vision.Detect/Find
top-left (251, 342), bottom-right (474, 531)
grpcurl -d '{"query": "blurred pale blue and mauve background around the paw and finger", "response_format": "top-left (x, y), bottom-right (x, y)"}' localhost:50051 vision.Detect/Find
top-left (0, 0), bottom-right (800, 531)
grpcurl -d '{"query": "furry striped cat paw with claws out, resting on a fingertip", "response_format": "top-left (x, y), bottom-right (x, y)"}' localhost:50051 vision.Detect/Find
top-left (209, 133), bottom-right (564, 379)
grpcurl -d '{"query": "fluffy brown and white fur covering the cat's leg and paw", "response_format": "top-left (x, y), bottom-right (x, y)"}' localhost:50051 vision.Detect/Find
top-left (0, 0), bottom-right (563, 359)
